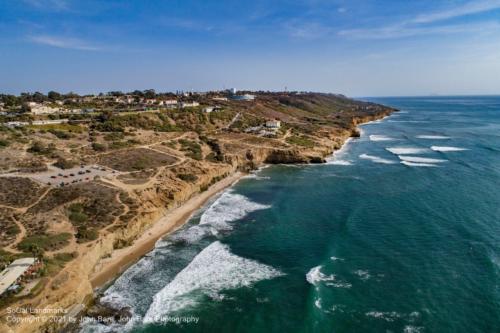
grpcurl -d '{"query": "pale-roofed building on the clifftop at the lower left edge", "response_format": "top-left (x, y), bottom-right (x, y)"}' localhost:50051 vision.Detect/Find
top-left (0, 258), bottom-right (41, 295)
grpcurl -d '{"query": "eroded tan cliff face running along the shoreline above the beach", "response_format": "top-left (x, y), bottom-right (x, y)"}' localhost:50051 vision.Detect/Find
top-left (0, 111), bottom-right (390, 332)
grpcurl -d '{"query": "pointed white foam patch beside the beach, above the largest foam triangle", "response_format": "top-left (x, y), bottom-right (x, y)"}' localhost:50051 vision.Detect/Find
top-left (200, 191), bottom-right (271, 230)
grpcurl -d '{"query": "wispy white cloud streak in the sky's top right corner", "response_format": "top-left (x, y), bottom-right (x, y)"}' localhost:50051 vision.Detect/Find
top-left (411, 0), bottom-right (500, 23)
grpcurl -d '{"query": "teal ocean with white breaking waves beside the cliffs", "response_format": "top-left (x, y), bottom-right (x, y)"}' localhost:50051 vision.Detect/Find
top-left (82, 97), bottom-right (500, 332)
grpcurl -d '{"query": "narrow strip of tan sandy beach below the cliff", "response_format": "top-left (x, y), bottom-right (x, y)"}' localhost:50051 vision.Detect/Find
top-left (90, 172), bottom-right (244, 288)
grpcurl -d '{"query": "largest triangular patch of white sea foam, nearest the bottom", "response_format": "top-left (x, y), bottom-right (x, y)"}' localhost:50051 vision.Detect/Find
top-left (143, 241), bottom-right (283, 323)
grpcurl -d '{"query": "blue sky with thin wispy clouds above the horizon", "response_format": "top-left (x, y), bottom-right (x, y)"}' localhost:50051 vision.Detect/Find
top-left (0, 0), bottom-right (500, 96)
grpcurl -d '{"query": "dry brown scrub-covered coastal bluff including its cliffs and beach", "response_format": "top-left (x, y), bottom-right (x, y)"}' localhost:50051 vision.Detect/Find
top-left (0, 93), bottom-right (396, 332)
